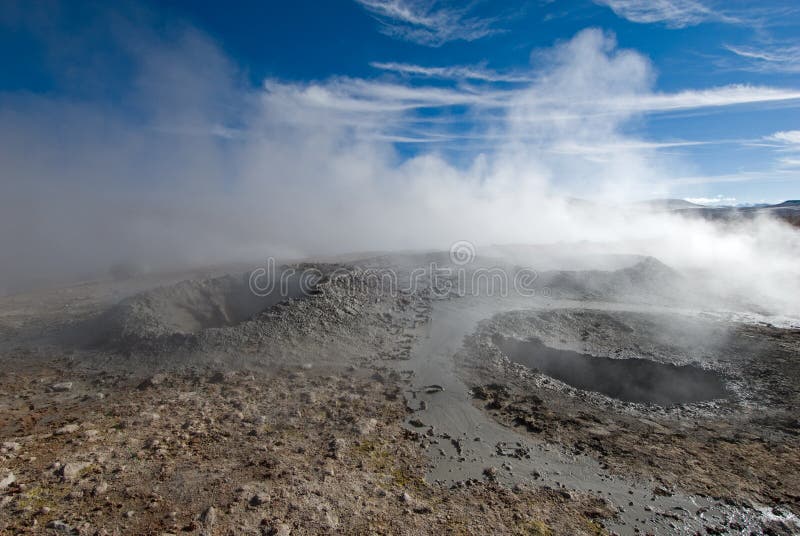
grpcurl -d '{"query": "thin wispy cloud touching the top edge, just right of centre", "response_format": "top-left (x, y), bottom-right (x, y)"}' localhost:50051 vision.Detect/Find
top-left (355, 0), bottom-right (502, 47)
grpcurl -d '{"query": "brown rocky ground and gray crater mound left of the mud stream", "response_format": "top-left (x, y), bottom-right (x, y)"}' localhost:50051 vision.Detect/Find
top-left (0, 267), bottom-right (612, 535)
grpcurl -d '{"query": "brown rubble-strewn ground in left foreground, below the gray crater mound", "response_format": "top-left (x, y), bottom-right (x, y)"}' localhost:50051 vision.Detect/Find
top-left (0, 363), bottom-right (608, 534)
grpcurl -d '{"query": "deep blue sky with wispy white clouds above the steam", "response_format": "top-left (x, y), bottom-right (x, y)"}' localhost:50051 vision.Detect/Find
top-left (0, 0), bottom-right (800, 203)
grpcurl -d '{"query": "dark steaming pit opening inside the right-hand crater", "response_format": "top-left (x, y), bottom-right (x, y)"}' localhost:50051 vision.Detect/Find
top-left (493, 336), bottom-right (730, 406)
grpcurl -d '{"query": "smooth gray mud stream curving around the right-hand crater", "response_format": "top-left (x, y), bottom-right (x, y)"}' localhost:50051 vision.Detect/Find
top-left (403, 298), bottom-right (800, 534)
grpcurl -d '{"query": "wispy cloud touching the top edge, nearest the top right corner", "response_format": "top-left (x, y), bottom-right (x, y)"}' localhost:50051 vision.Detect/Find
top-left (594, 0), bottom-right (729, 28)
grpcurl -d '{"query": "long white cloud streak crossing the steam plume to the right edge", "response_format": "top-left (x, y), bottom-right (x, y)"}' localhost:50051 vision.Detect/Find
top-left (265, 73), bottom-right (800, 134)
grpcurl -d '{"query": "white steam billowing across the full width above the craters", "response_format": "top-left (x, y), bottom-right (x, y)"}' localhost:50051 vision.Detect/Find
top-left (0, 8), bottom-right (800, 312)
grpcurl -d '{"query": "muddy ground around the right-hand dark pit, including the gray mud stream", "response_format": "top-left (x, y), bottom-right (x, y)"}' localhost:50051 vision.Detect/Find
top-left (434, 300), bottom-right (798, 534)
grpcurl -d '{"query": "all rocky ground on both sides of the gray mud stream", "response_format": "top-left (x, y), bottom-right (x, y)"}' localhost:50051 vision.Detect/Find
top-left (0, 255), bottom-right (800, 534)
